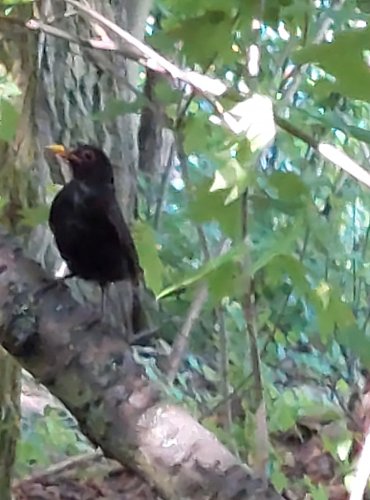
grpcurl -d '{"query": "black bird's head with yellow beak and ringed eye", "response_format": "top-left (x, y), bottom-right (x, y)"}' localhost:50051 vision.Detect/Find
top-left (46, 144), bottom-right (113, 184)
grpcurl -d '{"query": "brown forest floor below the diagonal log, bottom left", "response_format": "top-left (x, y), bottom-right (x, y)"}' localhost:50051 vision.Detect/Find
top-left (13, 374), bottom-right (159, 500)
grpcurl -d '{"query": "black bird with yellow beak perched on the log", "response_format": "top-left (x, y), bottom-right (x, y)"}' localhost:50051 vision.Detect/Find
top-left (46, 144), bottom-right (142, 326)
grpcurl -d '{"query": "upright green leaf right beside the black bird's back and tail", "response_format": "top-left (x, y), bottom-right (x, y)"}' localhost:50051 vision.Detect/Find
top-left (133, 221), bottom-right (163, 294)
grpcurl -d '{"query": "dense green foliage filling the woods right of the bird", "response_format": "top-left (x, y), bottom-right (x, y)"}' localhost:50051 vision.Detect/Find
top-left (0, 0), bottom-right (370, 498)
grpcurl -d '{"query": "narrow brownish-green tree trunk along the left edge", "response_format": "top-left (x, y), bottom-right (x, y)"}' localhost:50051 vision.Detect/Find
top-left (0, 7), bottom-right (37, 500)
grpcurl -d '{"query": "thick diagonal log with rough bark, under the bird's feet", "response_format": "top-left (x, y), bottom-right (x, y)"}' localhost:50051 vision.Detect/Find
top-left (0, 228), bottom-right (280, 500)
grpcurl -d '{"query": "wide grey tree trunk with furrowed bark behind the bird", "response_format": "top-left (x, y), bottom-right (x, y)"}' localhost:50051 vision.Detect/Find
top-left (28, 0), bottom-right (151, 269)
